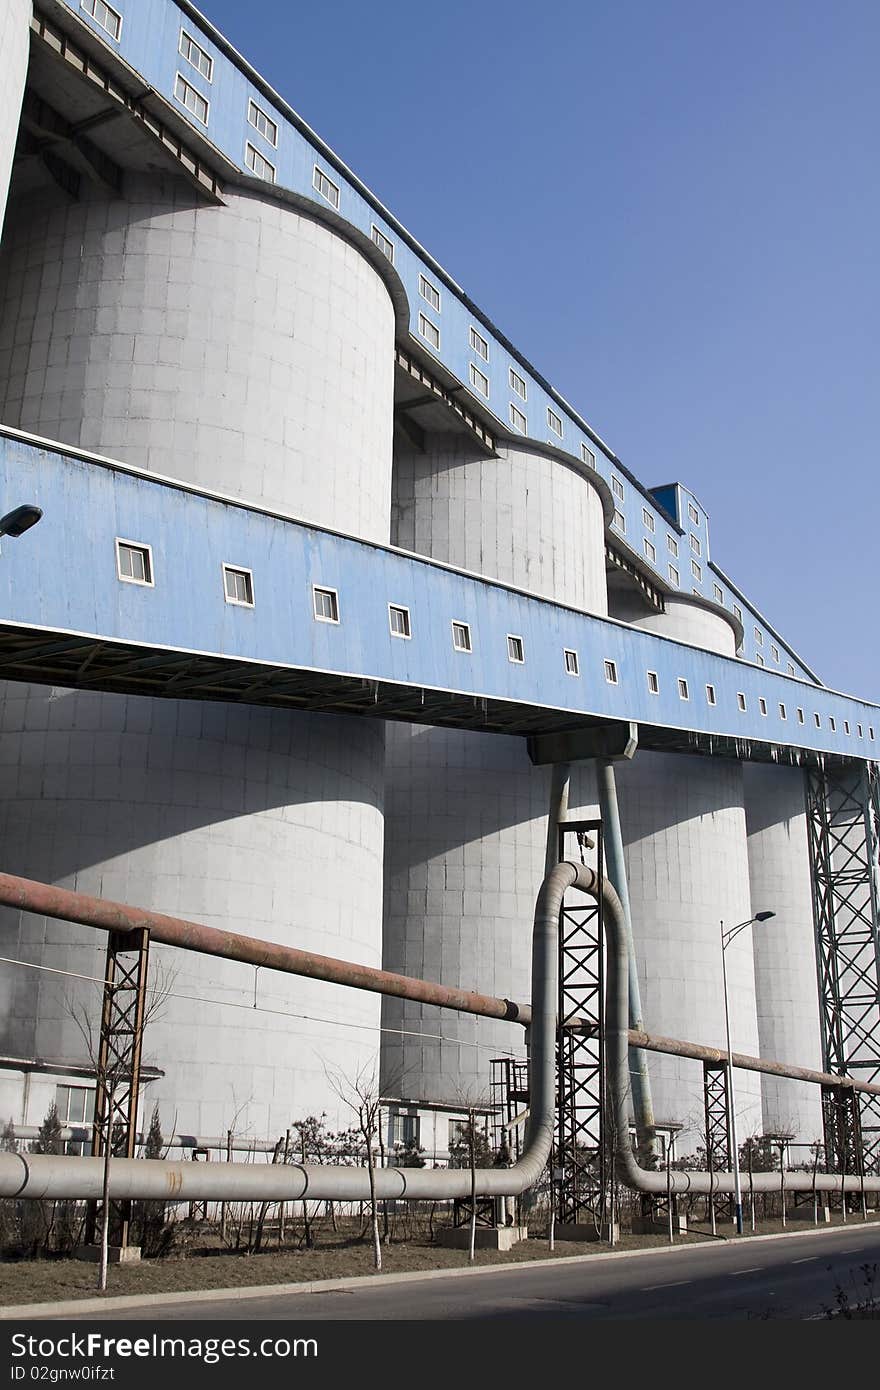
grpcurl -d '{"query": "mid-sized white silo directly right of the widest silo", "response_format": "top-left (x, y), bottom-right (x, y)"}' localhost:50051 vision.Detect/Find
top-left (382, 434), bottom-right (608, 1104)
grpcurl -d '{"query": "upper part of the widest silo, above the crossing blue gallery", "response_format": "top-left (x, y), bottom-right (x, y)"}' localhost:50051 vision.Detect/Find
top-left (0, 175), bottom-right (393, 541)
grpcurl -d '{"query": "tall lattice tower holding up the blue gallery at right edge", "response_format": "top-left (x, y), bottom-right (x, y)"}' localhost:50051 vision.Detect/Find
top-left (806, 763), bottom-right (880, 1175)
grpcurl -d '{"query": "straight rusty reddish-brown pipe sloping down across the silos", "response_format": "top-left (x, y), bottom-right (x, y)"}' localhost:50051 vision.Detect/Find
top-left (0, 873), bottom-right (880, 1095)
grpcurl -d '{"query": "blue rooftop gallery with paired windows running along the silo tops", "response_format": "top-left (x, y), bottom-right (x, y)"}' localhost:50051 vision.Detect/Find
top-left (47, 0), bottom-right (810, 678)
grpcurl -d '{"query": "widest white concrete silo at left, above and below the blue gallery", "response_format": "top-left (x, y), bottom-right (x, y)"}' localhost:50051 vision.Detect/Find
top-left (0, 177), bottom-right (395, 1136)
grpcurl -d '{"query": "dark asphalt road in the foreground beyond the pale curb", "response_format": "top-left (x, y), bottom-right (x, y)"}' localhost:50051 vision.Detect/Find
top-left (73, 1220), bottom-right (880, 1322)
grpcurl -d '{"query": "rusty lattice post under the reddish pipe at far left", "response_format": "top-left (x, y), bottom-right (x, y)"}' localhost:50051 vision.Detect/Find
top-left (86, 929), bottom-right (150, 1247)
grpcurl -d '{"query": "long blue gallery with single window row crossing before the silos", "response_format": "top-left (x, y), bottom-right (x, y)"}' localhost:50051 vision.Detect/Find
top-left (0, 435), bottom-right (880, 759)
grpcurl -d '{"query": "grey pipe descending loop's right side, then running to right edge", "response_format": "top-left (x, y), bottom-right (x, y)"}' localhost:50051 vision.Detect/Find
top-left (605, 884), bottom-right (880, 1197)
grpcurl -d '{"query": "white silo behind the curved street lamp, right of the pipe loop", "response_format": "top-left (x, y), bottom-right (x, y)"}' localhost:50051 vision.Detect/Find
top-left (612, 596), bottom-right (763, 1154)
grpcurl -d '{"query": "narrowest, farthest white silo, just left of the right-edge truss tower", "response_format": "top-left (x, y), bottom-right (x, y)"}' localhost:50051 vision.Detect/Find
top-left (744, 765), bottom-right (822, 1145)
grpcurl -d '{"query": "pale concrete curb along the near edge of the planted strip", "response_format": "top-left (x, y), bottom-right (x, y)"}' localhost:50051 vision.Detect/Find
top-left (0, 1218), bottom-right (877, 1322)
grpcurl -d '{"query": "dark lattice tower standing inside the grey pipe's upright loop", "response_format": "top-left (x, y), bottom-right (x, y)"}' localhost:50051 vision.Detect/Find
top-left (556, 821), bottom-right (610, 1229)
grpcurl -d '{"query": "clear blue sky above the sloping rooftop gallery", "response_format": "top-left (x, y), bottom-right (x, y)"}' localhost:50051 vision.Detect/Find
top-left (202, 0), bottom-right (880, 699)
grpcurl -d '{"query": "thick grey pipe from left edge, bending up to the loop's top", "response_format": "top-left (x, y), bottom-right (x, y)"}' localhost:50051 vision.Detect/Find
top-left (0, 863), bottom-right (589, 1201)
